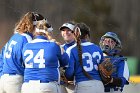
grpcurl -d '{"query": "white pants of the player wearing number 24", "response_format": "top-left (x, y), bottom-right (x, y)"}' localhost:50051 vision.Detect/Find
top-left (21, 80), bottom-right (61, 93)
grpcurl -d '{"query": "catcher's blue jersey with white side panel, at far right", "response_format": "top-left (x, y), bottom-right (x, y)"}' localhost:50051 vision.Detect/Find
top-left (105, 56), bottom-right (129, 90)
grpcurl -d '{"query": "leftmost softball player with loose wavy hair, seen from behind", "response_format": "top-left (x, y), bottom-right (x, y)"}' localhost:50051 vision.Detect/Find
top-left (0, 12), bottom-right (43, 93)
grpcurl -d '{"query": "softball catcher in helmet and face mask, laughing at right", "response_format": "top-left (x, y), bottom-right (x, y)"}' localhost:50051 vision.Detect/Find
top-left (99, 32), bottom-right (129, 93)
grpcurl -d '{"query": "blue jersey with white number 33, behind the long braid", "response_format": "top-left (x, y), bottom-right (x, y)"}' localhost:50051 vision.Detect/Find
top-left (65, 42), bottom-right (103, 82)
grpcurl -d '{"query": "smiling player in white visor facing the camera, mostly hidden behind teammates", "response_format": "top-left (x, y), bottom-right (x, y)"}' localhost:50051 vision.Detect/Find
top-left (59, 22), bottom-right (75, 93)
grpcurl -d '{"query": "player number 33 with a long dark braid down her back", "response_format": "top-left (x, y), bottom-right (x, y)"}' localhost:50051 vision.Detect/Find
top-left (65, 23), bottom-right (104, 93)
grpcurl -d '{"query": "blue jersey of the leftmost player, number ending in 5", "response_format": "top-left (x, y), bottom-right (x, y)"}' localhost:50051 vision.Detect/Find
top-left (3, 33), bottom-right (32, 75)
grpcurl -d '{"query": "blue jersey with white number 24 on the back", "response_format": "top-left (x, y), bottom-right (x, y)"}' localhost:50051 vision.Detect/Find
top-left (22, 36), bottom-right (69, 83)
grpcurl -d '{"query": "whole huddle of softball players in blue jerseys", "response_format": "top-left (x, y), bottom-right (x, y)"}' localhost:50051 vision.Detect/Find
top-left (0, 12), bottom-right (129, 93)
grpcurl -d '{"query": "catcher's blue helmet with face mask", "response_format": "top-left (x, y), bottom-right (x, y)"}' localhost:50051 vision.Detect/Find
top-left (99, 32), bottom-right (122, 55)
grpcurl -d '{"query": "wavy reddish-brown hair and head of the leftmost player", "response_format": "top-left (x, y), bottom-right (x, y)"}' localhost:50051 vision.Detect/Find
top-left (15, 12), bottom-right (44, 33)
